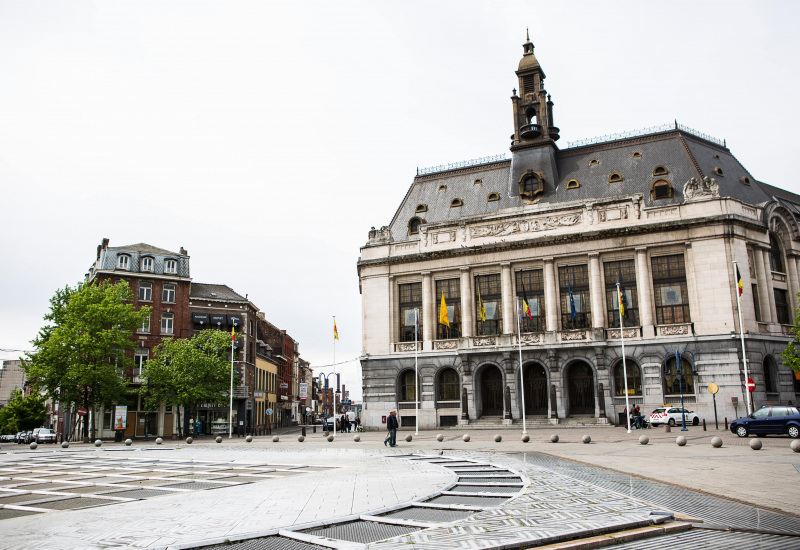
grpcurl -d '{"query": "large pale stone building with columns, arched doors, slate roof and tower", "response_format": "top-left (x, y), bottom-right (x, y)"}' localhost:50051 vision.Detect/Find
top-left (358, 35), bottom-right (800, 427)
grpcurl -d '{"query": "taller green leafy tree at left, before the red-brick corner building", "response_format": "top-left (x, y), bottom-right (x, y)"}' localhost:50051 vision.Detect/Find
top-left (22, 281), bottom-right (150, 435)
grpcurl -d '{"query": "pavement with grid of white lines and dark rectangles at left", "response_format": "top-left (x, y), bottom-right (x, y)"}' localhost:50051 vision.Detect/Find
top-left (0, 453), bottom-right (328, 520)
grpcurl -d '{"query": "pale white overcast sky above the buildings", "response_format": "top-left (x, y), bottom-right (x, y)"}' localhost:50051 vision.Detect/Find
top-left (0, 0), bottom-right (800, 398)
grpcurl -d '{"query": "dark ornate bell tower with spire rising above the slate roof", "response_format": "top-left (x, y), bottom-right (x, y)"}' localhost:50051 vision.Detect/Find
top-left (511, 33), bottom-right (559, 151)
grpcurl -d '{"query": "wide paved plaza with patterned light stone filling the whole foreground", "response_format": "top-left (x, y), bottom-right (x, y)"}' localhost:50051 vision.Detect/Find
top-left (0, 427), bottom-right (800, 550)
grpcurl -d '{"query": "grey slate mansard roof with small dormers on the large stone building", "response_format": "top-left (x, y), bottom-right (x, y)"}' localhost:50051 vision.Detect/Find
top-left (382, 128), bottom-right (800, 242)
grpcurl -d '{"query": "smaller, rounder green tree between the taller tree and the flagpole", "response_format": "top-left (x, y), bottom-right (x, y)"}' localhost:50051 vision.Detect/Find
top-left (139, 330), bottom-right (238, 438)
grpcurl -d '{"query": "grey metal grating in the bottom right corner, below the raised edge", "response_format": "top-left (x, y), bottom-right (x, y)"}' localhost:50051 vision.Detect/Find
top-left (606, 529), bottom-right (800, 550)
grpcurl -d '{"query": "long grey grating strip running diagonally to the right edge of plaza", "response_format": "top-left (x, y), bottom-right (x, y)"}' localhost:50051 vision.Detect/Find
top-left (510, 452), bottom-right (800, 534)
